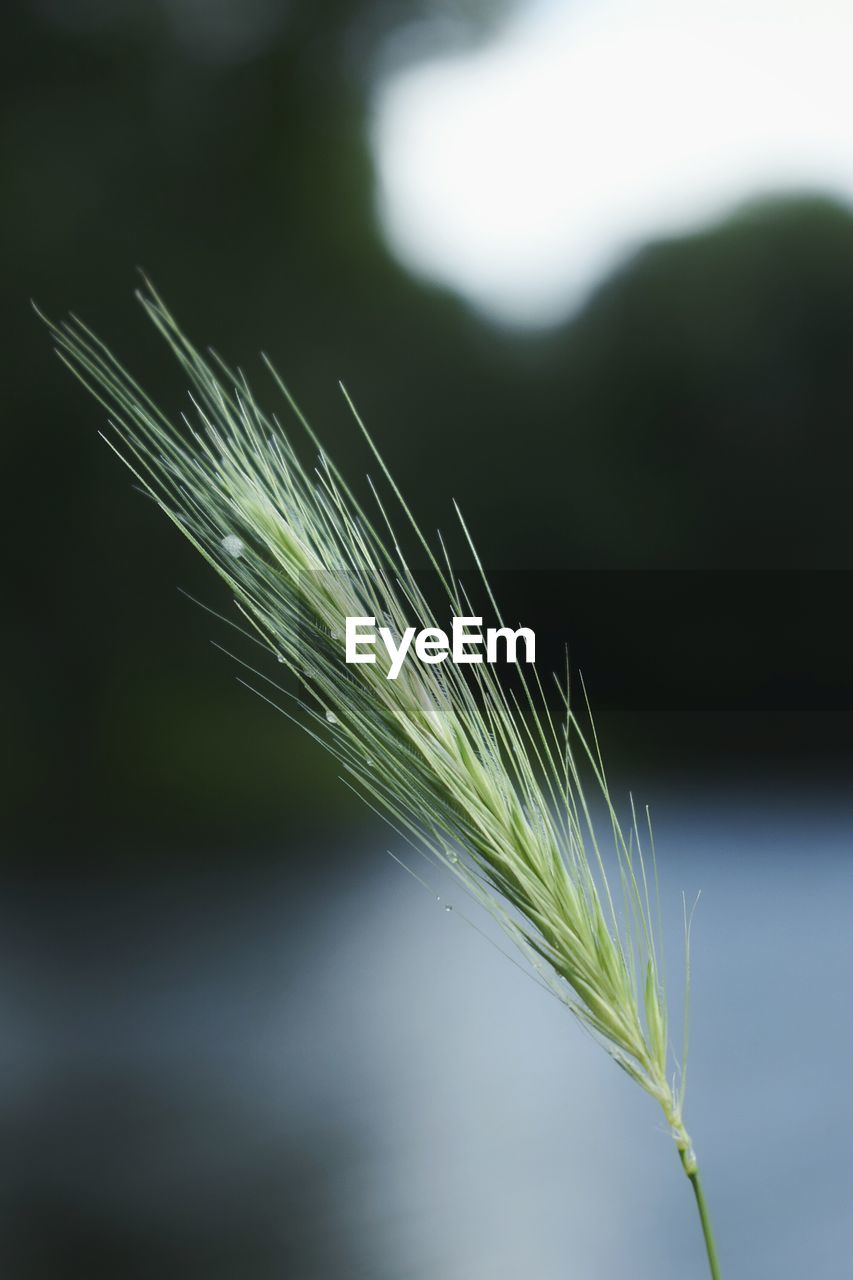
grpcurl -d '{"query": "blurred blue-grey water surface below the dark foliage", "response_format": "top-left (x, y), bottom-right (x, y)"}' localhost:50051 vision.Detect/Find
top-left (0, 796), bottom-right (853, 1280)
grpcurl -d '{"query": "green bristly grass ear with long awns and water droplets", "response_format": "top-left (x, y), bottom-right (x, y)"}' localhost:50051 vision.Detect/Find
top-left (39, 288), bottom-right (719, 1277)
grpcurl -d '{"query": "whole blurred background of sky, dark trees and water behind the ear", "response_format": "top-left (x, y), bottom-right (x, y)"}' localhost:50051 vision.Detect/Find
top-left (0, 0), bottom-right (853, 1280)
